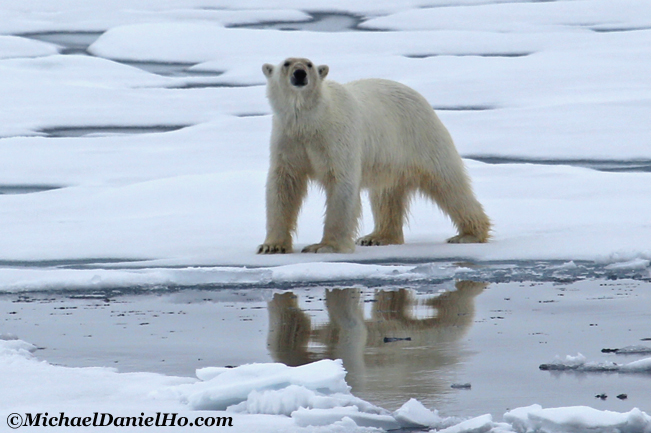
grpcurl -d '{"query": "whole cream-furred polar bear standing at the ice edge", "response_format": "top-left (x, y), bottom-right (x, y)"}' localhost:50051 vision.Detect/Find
top-left (258, 58), bottom-right (490, 254)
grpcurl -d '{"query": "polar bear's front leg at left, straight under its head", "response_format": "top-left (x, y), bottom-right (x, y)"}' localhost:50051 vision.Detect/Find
top-left (258, 167), bottom-right (307, 254)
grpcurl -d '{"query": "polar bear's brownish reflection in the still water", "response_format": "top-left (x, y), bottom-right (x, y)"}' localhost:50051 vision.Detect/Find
top-left (267, 281), bottom-right (487, 402)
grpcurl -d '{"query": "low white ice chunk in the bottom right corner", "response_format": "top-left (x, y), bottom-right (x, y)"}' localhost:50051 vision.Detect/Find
top-left (504, 405), bottom-right (651, 433)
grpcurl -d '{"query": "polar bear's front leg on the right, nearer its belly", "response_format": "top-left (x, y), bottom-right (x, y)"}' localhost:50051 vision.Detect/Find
top-left (302, 176), bottom-right (361, 253)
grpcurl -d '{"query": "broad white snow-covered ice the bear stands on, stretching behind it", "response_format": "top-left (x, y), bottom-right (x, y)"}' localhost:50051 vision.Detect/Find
top-left (0, 0), bottom-right (651, 274)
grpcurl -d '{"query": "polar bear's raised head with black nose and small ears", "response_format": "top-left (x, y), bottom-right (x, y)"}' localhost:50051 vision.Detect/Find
top-left (262, 57), bottom-right (330, 114)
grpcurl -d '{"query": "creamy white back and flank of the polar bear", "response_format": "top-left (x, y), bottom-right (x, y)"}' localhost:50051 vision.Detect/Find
top-left (334, 79), bottom-right (464, 187)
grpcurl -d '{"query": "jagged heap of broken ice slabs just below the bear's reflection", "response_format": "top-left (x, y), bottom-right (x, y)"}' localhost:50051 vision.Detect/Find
top-left (177, 360), bottom-right (408, 430)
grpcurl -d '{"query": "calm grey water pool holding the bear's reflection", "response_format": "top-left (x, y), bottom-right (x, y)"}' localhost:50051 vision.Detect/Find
top-left (0, 271), bottom-right (651, 419)
